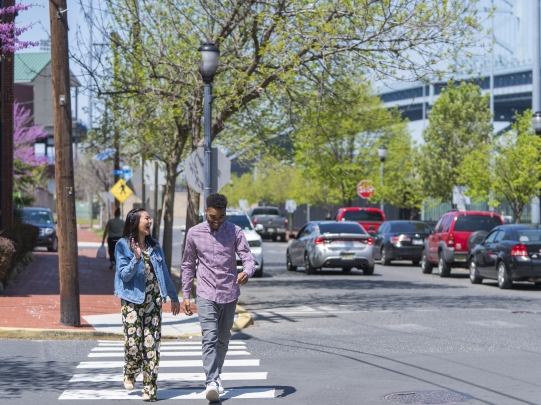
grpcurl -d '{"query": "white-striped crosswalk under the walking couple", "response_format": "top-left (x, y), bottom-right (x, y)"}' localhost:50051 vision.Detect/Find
top-left (58, 340), bottom-right (276, 401)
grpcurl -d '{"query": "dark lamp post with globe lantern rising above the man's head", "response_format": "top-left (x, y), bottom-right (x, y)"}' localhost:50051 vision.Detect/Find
top-left (199, 42), bottom-right (220, 208)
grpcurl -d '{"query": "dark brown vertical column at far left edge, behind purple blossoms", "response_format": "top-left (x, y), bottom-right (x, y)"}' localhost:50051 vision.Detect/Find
top-left (0, 0), bottom-right (15, 229)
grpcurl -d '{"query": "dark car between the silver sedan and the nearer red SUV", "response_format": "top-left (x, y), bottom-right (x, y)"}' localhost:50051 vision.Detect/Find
top-left (374, 221), bottom-right (432, 265)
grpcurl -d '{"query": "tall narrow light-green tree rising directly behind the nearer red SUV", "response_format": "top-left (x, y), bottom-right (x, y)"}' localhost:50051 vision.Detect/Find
top-left (419, 82), bottom-right (492, 201)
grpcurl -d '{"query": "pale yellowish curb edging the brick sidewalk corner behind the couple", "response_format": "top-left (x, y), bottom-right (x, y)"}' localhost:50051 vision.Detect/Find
top-left (0, 305), bottom-right (254, 340)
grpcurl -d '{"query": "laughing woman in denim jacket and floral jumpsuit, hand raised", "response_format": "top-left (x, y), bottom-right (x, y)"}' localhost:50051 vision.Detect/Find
top-left (115, 208), bottom-right (180, 402)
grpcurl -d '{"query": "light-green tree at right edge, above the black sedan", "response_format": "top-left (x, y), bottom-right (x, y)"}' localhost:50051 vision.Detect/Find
top-left (459, 110), bottom-right (541, 223)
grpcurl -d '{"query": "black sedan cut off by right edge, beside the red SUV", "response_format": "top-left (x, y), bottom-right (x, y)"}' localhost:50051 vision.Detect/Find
top-left (469, 225), bottom-right (541, 288)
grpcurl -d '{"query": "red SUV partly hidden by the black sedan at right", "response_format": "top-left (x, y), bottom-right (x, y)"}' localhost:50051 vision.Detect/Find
top-left (421, 211), bottom-right (503, 277)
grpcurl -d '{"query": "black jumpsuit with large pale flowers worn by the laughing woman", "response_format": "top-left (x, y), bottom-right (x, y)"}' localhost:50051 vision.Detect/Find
top-left (121, 254), bottom-right (162, 401)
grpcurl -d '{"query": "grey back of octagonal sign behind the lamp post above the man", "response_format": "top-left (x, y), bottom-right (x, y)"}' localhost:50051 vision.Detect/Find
top-left (184, 148), bottom-right (231, 193)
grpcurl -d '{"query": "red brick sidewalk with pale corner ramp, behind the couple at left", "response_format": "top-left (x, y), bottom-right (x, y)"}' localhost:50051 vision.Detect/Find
top-left (0, 229), bottom-right (251, 339)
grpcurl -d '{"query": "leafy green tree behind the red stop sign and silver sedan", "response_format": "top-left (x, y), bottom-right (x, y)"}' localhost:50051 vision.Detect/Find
top-left (294, 79), bottom-right (407, 206)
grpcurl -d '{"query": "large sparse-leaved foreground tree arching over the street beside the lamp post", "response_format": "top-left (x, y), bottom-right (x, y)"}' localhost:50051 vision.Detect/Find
top-left (78, 0), bottom-right (479, 272)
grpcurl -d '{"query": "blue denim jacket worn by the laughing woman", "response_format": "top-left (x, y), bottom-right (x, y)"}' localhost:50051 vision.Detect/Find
top-left (115, 238), bottom-right (179, 304)
